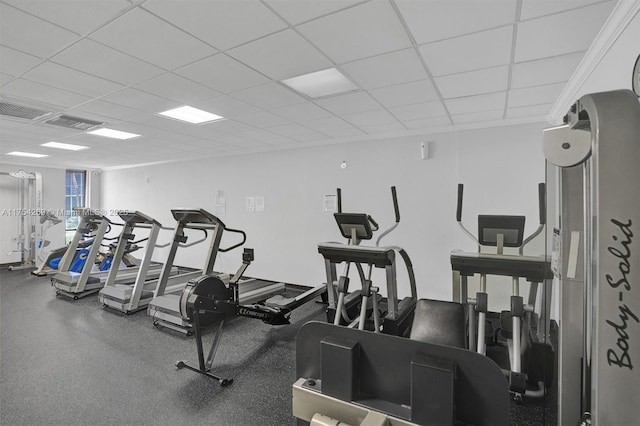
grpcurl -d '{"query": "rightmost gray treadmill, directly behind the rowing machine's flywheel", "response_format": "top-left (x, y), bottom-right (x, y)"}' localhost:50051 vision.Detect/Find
top-left (147, 209), bottom-right (285, 335)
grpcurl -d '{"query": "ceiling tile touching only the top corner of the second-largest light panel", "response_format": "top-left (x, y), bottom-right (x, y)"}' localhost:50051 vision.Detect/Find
top-left (135, 73), bottom-right (221, 105)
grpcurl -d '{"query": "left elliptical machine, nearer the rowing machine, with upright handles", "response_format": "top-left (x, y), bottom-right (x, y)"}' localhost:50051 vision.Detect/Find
top-left (318, 186), bottom-right (417, 336)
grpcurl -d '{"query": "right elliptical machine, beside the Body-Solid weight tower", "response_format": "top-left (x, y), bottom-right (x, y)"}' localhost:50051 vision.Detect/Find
top-left (451, 183), bottom-right (554, 401)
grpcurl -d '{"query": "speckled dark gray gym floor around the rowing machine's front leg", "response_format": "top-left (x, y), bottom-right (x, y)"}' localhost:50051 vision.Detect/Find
top-left (0, 268), bottom-right (556, 426)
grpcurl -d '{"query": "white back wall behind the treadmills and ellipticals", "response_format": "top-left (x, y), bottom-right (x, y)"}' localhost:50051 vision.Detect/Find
top-left (101, 124), bottom-right (545, 300)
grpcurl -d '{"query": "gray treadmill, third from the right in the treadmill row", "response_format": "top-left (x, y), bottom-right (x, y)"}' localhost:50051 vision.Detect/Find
top-left (51, 207), bottom-right (168, 300)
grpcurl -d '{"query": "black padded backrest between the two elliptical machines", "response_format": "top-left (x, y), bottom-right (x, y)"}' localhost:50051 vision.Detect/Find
top-left (409, 299), bottom-right (466, 348)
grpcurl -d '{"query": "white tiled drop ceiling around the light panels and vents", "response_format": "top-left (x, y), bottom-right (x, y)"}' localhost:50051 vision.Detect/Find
top-left (0, 0), bottom-right (616, 169)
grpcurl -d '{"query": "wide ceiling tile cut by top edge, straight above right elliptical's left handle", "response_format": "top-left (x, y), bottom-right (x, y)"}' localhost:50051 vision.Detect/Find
top-left (396, 0), bottom-right (517, 44)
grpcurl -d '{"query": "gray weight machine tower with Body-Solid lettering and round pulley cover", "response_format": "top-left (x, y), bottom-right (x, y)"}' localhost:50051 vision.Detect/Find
top-left (544, 90), bottom-right (640, 426)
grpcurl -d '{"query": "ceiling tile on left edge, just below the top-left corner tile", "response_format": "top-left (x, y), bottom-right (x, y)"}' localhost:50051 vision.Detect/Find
top-left (0, 3), bottom-right (78, 58)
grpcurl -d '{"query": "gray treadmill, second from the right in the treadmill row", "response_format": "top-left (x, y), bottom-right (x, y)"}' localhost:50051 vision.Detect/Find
top-left (98, 211), bottom-right (201, 314)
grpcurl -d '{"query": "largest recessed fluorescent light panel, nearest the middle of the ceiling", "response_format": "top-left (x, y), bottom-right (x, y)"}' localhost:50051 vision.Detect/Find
top-left (282, 68), bottom-right (358, 98)
